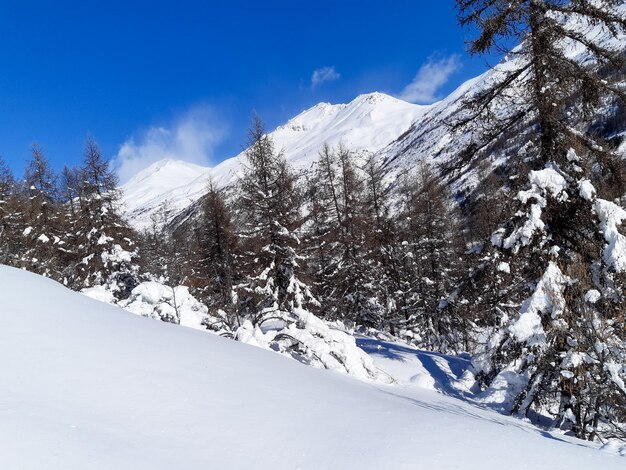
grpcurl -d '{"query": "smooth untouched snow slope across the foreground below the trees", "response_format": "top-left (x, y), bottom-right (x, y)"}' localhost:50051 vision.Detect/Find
top-left (0, 266), bottom-right (624, 470)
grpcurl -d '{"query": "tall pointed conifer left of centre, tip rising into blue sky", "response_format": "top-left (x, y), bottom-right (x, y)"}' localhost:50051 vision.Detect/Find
top-left (236, 118), bottom-right (315, 325)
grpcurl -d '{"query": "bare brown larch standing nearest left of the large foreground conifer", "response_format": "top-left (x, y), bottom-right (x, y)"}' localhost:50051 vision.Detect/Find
top-left (395, 163), bottom-right (468, 352)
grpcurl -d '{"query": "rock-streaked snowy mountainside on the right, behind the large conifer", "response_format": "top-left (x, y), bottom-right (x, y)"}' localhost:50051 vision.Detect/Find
top-left (380, 12), bottom-right (626, 193)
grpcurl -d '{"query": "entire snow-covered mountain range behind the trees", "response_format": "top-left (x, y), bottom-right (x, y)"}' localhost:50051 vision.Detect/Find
top-left (123, 11), bottom-right (626, 228)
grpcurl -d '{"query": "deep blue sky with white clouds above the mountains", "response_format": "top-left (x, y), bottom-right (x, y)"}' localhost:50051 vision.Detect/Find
top-left (0, 0), bottom-right (494, 177)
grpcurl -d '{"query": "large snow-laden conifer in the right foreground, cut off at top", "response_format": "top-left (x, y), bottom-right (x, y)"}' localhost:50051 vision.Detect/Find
top-left (450, 0), bottom-right (626, 439)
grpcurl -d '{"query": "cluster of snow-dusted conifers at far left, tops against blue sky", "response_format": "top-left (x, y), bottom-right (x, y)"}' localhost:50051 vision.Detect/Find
top-left (0, 138), bottom-right (139, 298)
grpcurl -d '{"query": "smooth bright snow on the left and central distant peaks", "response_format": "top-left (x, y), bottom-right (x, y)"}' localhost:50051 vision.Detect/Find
top-left (122, 93), bottom-right (428, 229)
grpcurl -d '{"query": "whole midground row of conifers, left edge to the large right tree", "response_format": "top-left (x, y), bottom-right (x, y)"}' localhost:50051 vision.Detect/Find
top-left (0, 120), bottom-right (469, 352)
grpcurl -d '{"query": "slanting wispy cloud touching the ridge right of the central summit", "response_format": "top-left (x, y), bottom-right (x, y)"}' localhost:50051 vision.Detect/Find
top-left (398, 54), bottom-right (461, 104)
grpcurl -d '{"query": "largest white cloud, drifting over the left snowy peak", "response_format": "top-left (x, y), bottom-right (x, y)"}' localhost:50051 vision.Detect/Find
top-left (113, 106), bottom-right (226, 183)
